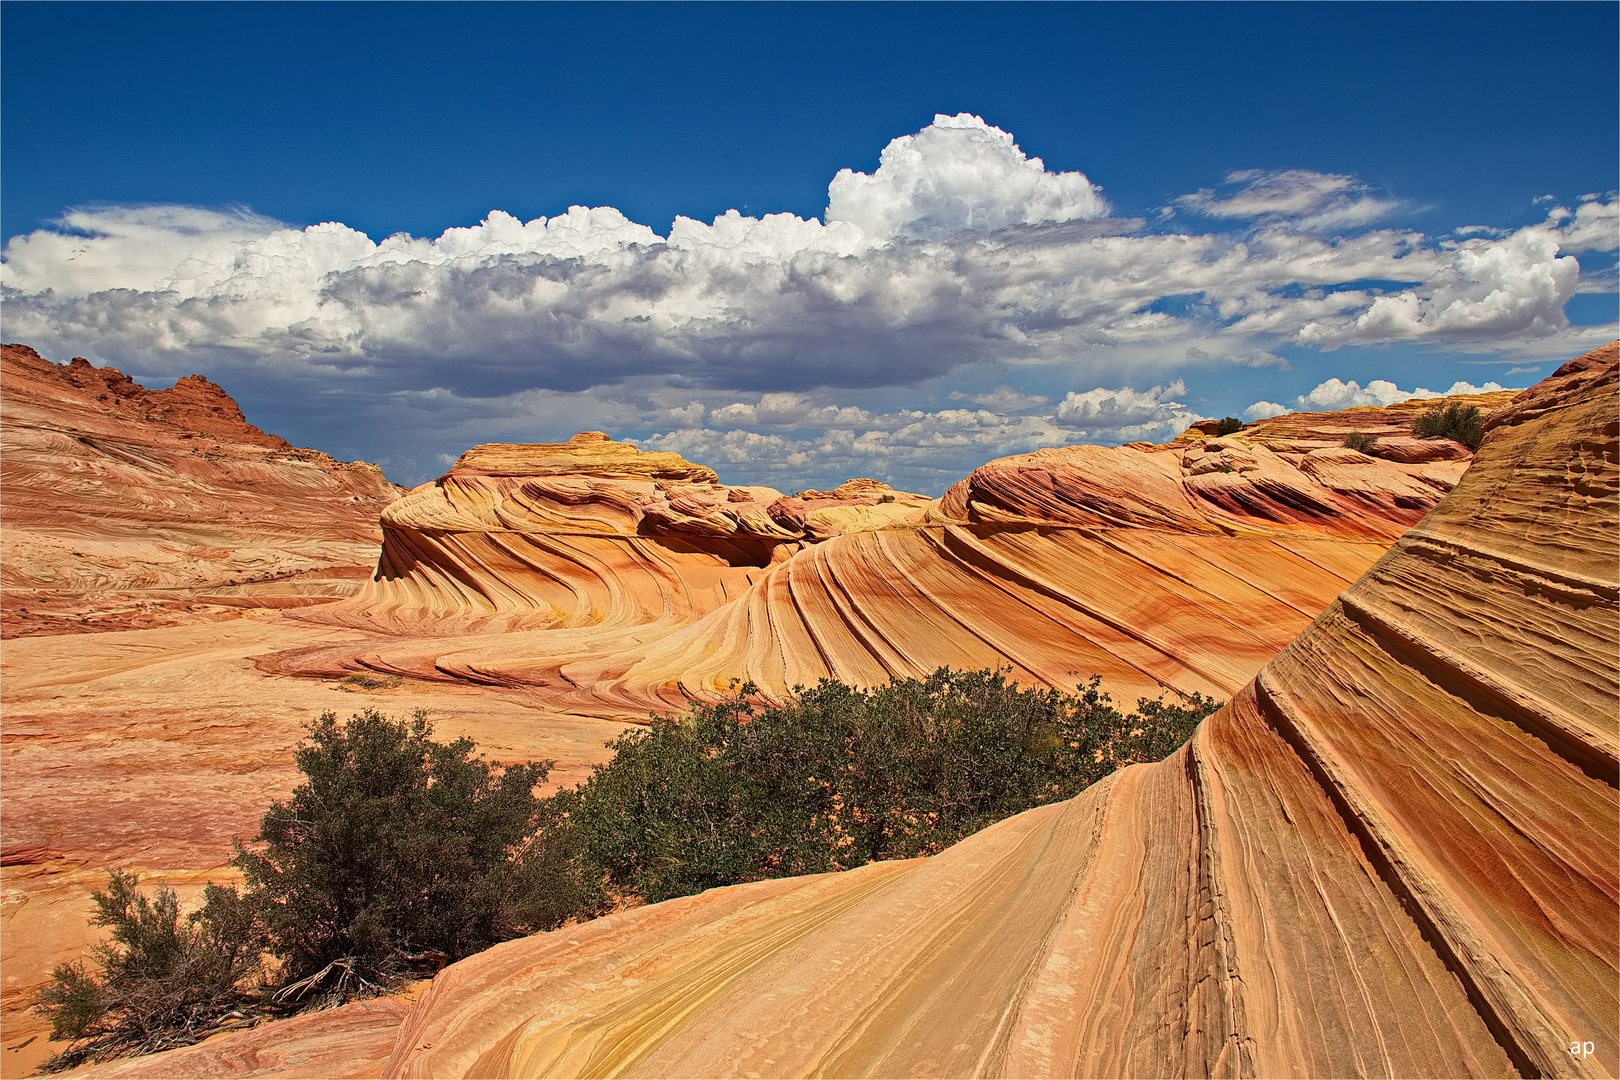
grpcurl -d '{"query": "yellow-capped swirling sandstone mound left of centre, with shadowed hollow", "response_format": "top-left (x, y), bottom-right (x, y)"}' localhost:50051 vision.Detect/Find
top-left (296, 432), bottom-right (928, 631)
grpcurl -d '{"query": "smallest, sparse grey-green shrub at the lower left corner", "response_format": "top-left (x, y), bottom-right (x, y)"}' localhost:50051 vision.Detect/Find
top-left (39, 870), bottom-right (259, 1070)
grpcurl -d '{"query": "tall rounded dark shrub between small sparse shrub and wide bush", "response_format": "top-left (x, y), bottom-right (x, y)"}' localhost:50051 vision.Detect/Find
top-left (232, 709), bottom-right (551, 1001)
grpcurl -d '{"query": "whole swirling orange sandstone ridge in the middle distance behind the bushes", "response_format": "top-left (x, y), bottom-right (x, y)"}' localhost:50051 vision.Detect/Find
top-left (281, 393), bottom-right (1511, 719)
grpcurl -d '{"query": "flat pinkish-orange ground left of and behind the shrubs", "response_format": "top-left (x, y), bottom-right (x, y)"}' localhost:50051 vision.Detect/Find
top-left (0, 612), bottom-right (624, 1077)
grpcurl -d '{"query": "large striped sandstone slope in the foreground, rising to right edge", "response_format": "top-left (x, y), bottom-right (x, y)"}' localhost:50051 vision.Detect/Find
top-left (361, 347), bottom-right (1620, 1077)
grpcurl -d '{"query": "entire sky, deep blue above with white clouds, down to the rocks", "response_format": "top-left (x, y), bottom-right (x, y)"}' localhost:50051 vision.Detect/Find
top-left (0, 2), bottom-right (1620, 491)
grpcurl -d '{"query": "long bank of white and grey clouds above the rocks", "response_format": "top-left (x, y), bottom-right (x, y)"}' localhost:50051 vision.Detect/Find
top-left (0, 113), bottom-right (1617, 479)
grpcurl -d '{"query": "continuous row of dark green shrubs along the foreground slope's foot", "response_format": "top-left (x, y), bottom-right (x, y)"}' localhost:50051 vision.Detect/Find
top-left (37, 680), bottom-right (1217, 1069)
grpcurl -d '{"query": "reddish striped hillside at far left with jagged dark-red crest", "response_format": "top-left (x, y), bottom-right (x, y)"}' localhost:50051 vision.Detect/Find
top-left (0, 345), bottom-right (397, 638)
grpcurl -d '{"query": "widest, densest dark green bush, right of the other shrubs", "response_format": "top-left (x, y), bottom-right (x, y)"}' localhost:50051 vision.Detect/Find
top-left (538, 669), bottom-right (1217, 910)
